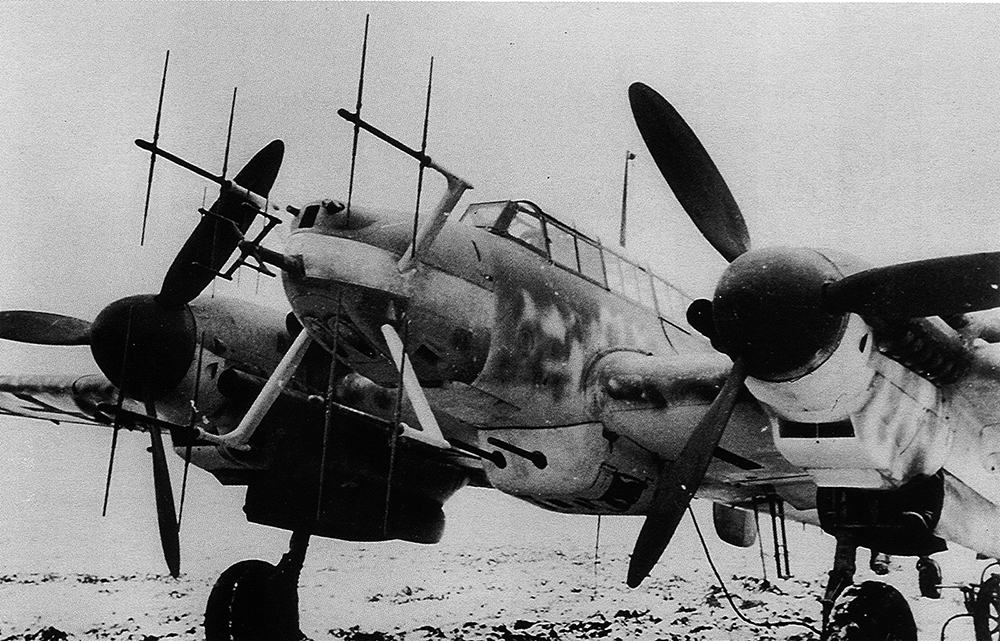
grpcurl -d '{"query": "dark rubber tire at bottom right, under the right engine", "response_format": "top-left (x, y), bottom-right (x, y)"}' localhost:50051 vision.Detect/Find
top-left (825, 581), bottom-right (917, 641)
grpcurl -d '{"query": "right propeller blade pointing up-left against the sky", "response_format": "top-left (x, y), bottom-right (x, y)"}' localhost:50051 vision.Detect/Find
top-left (628, 82), bottom-right (750, 262)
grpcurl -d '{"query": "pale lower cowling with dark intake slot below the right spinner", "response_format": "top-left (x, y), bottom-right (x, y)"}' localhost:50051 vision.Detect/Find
top-left (746, 315), bottom-right (951, 489)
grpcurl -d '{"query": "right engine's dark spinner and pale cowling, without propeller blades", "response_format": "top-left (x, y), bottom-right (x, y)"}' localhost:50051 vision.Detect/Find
top-left (712, 248), bottom-right (950, 488)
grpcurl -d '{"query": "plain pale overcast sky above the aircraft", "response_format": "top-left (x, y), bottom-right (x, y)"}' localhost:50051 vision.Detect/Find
top-left (0, 2), bottom-right (1000, 369)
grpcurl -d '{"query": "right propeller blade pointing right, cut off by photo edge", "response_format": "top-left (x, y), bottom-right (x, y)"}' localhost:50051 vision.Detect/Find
top-left (823, 253), bottom-right (1000, 318)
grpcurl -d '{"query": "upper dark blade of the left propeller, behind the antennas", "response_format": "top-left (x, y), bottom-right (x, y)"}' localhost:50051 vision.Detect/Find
top-left (156, 140), bottom-right (285, 308)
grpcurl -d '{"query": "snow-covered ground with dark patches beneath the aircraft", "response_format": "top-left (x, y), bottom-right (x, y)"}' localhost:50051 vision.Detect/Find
top-left (0, 419), bottom-right (985, 641)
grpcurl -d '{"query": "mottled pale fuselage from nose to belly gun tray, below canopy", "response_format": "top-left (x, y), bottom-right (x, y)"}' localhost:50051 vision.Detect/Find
top-left (285, 200), bottom-right (776, 512)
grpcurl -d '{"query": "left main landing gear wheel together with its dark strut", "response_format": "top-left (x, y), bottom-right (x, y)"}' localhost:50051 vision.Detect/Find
top-left (205, 532), bottom-right (309, 641)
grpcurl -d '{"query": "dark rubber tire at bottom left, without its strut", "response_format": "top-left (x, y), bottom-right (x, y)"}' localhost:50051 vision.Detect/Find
top-left (205, 559), bottom-right (292, 641)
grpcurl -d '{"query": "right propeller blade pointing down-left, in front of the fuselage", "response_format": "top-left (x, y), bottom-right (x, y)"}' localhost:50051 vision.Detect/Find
top-left (626, 359), bottom-right (747, 588)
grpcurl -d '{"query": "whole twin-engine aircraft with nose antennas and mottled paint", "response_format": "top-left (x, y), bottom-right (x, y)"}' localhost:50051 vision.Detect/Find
top-left (0, 48), bottom-right (1000, 641)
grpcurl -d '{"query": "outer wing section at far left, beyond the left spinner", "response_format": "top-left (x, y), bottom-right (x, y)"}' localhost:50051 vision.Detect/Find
top-left (0, 374), bottom-right (142, 425)
